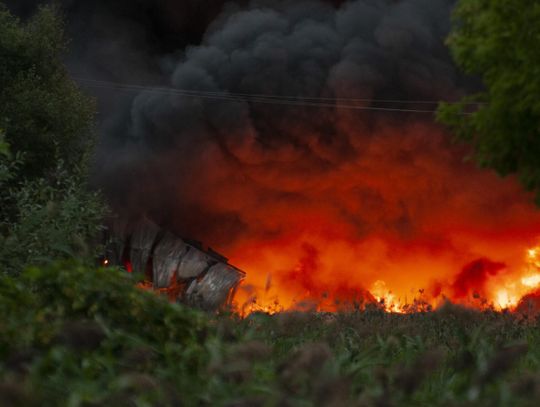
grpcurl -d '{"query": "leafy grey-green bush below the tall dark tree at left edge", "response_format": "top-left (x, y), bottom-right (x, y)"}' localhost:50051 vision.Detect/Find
top-left (0, 161), bottom-right (105, 275)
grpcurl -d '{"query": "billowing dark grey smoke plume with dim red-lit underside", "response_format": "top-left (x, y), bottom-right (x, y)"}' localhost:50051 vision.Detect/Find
top-left (89, 0), bottom-right (459, 240)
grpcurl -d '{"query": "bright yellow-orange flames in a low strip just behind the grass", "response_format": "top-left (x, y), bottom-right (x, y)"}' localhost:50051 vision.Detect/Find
top-left (236, 242), bottom-right (540, 314)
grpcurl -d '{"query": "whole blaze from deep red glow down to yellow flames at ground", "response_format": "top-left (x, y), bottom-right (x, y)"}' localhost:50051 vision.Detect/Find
top-left (167, 126), bottom-right (540, 313)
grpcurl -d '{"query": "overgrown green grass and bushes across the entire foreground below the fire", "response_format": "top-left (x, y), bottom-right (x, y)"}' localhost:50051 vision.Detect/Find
top-left (0, 264), bottom-right (540, 406)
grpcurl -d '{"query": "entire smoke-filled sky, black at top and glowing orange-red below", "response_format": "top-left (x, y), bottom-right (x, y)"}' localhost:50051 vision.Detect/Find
top-left (9, 0), bottom-right (540, 310)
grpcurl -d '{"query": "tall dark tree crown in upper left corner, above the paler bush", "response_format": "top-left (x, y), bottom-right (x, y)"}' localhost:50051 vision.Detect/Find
top-left (0, 3), bottom-right (94, 178)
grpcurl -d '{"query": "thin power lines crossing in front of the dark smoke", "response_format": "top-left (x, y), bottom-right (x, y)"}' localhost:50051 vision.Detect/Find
top-left (74, 77), bottom-right (481, 114)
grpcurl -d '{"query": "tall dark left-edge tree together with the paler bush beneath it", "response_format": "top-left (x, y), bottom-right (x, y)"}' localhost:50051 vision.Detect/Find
top-left (0, 3), bottom-right (104, 274)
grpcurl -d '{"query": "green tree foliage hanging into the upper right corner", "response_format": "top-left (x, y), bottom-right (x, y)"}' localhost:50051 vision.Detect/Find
top-left (438, 0), bottom-right (540, 205)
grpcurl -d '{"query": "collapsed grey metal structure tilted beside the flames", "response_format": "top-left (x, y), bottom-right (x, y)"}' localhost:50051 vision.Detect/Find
top-left (107, 218), bottom-right (245, 311)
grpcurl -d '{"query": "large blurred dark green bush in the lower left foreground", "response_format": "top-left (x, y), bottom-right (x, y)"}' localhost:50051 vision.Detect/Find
top-left (0, 264), bottom-right (206, 406)
